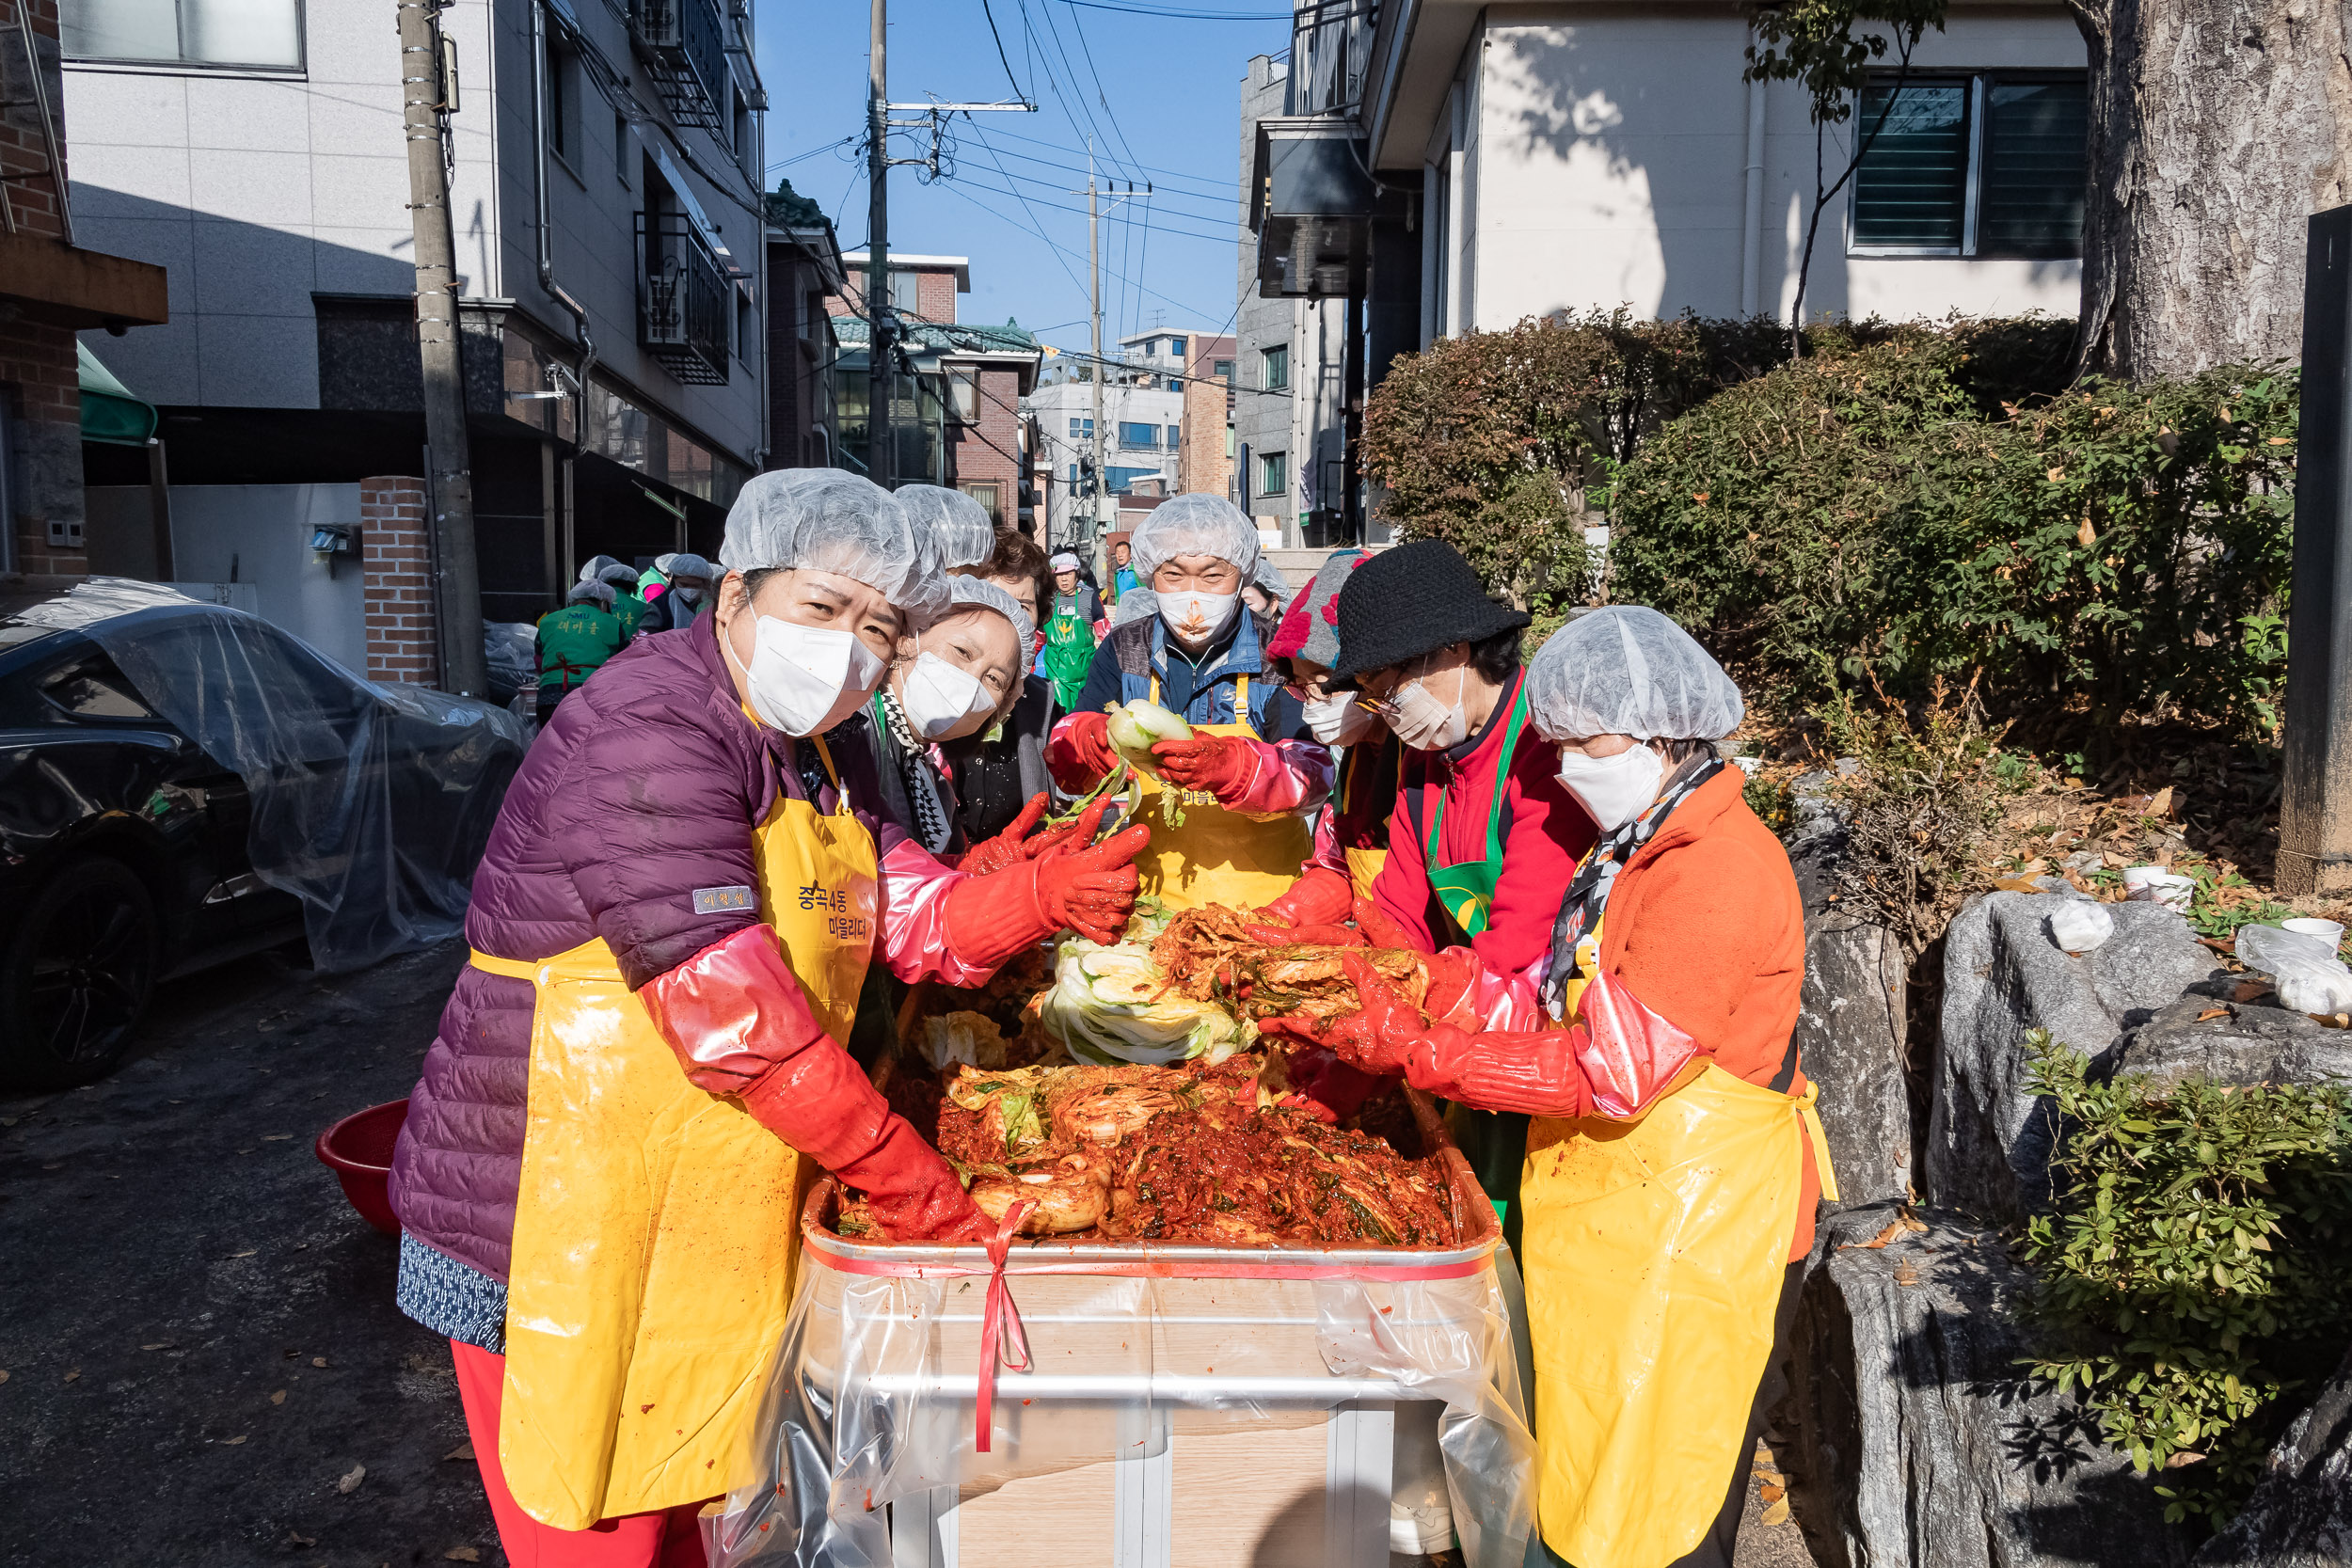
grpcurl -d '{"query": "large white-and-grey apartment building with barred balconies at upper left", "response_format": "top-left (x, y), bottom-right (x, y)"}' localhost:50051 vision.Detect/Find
top-left (61, 0), bottom-right (770, 641)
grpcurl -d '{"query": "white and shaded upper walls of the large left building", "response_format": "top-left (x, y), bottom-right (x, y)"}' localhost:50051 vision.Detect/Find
top-left (66, 0), bottom-right (767, 466)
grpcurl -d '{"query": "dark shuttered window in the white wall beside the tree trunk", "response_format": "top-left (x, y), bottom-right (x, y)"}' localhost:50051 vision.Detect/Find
top-left (1849, 71), bottom-right (2089, 259)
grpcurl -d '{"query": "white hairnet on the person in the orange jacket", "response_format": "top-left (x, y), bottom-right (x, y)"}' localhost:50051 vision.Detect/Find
top-left (1527, 604), bottom-right (1748, 740)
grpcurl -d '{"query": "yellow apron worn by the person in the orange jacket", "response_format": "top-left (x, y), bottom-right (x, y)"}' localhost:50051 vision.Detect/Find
top-left (1519, 1060), bottom-right (1837, 1568)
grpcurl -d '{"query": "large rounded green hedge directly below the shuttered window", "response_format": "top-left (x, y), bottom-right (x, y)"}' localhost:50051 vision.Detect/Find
top-left (1609, 325), bottom-right (2298, 729)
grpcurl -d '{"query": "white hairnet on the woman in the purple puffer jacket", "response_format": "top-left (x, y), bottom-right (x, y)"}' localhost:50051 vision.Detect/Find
top-left (720, 467), bottom-right (948, 621)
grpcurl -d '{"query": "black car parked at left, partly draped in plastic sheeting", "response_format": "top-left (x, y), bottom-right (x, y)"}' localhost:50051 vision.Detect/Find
top-left (0, 602), bottom-right (527, 1088)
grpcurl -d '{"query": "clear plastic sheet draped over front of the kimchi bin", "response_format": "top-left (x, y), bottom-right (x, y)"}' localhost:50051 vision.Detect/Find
top-left (704, 1194), bottom-right (1536, 1568)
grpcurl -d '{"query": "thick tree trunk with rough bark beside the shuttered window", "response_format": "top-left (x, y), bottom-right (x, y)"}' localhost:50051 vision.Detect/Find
top-left (2070, 0), bottom-right (2352, 381)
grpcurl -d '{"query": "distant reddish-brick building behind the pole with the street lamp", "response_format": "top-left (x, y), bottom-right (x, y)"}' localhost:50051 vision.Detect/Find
top-left (826, 251), bottom-right (1044, 512)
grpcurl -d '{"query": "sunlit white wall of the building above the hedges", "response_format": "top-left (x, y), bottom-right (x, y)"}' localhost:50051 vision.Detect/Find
top-left (1433, 5), bottom-right (2084, 329)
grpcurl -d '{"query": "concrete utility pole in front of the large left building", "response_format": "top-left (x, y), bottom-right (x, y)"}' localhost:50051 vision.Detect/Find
top-left (398, 0), bottom-right (486, 696)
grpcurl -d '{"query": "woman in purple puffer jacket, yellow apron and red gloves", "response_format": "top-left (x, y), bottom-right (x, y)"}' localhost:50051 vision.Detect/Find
top-left (393, 470), bottom-right (1146, 1568)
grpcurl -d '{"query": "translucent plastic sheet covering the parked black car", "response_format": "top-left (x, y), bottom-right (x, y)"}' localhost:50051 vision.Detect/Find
top-left (19, 578), bottom-right (530, 971)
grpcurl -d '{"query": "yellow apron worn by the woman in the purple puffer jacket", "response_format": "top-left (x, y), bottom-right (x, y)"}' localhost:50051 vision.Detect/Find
top-left (494, 740), bottom-right (878, 1530)
